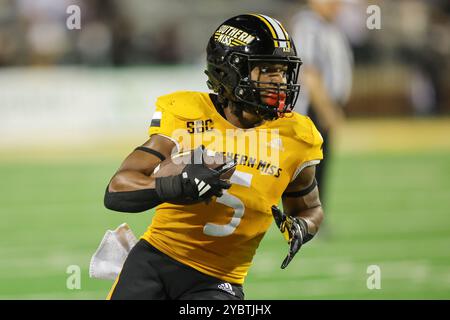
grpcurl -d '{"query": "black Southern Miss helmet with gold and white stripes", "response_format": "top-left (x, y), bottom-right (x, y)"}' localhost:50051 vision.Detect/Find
top-left (205, 14), bottom-right (302, 120)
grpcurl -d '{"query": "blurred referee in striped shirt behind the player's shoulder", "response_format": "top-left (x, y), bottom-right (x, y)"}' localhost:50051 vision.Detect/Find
top-left (291, 0), bottom-right (353, 205)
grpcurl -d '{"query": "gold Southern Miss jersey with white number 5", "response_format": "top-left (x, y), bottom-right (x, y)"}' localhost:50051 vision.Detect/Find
top-left (142, 91), bottom-right (323, 284)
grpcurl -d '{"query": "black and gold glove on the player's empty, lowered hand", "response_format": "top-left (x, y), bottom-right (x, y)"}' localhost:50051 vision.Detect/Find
top-left (272, 206), bottom-right (312, 269)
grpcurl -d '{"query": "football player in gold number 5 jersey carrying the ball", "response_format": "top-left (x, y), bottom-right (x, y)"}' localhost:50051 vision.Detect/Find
top-left (105, 14), bottom-right (323, 300)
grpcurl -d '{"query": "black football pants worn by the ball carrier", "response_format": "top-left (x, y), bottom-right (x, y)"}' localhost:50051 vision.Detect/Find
top-left (108, 239), bottom-right (244, 300)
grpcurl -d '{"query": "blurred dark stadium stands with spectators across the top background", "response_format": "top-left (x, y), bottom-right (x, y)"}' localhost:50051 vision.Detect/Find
top-left (0, 0), bottom-right (450, 121)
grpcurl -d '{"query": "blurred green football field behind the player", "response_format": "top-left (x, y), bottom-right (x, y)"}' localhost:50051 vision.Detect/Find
top-left (0, 119), bottom-right (450, 299)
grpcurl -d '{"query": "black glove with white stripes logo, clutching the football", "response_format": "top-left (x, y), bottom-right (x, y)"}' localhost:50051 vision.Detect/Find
top-left (156, 146), bottom-right (236, 203)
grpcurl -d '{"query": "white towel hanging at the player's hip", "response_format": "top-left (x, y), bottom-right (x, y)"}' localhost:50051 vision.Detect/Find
top-left (89, 223), bottom-right (137, 280)
